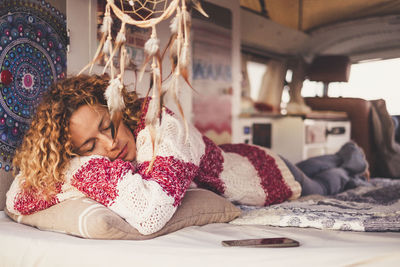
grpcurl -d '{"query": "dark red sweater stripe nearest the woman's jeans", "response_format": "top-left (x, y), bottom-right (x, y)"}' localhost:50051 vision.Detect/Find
top-left (220, 144), bottom-right (292, 206)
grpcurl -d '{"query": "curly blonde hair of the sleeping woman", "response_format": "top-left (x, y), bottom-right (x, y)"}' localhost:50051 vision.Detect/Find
top-left (13, 75), bottom-right (142, 197)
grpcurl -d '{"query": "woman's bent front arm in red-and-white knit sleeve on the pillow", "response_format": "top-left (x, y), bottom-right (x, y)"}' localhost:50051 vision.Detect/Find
top-left (67, 156), bottom-right (183, 234)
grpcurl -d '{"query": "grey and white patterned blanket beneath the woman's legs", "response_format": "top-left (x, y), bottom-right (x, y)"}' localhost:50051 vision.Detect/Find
top-left (231, 178), bottom-right (400, 232)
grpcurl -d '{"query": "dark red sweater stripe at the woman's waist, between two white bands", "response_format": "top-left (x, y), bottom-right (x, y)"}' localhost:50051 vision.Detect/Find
top-left (194, 136), bottom-right (225, 194)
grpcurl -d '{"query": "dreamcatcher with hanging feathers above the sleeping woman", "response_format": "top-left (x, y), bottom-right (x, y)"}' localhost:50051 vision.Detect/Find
top-left (80, 0), bottom-right (208, 170)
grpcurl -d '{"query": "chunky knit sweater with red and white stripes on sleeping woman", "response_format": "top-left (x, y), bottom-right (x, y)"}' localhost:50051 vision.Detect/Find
top-left (7, 98), bottom-right (301, 234)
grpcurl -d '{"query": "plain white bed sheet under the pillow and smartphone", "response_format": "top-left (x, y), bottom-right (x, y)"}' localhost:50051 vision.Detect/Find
top-left (0, 212), bottom-right (400, 267)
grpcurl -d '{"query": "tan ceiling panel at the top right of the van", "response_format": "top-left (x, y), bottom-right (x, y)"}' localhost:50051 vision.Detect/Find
top-left (240, 0), bottom-right (400, 32)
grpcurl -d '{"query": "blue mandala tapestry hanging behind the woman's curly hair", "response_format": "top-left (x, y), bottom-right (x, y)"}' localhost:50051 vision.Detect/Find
top-left (0, 0), bottom-right (68, 171)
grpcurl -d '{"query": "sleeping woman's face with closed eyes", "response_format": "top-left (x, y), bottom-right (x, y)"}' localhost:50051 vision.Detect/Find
top-left (69, 105), bottom-right (136, 161)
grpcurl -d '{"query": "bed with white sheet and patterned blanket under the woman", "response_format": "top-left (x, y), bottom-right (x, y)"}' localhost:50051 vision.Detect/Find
top-left (0, 179), bottom-right (400, 267)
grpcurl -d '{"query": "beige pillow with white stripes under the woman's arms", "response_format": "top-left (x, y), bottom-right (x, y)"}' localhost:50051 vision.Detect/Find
top-left (5, 189), bottom-right (240, 240)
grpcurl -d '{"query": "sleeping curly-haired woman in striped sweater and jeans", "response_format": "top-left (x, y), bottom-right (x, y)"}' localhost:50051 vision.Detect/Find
top-left (7, 75), bottom-right (368, 234)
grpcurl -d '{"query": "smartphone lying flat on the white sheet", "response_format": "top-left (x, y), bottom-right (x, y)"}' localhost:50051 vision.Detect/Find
top-left (221, 237), bottom-right (300, 248)
